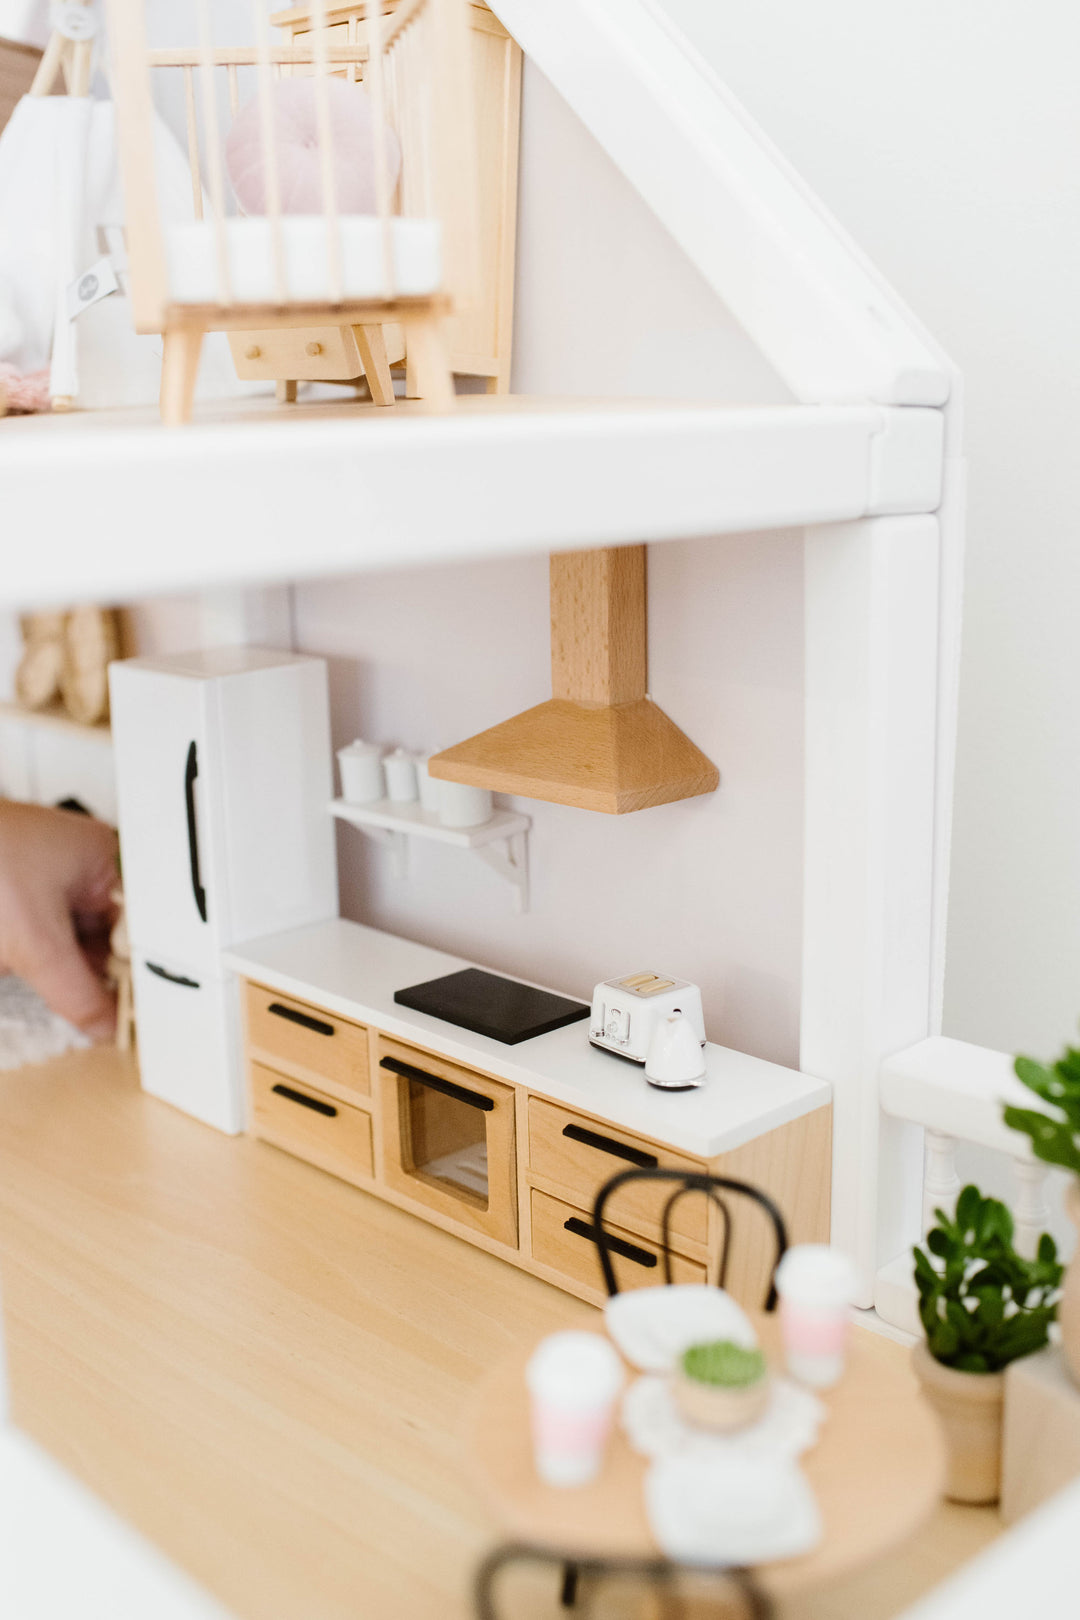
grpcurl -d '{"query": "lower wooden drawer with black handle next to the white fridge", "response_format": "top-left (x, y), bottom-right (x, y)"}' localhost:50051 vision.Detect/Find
top-left (251, 1063), bottom-right (374, 1181)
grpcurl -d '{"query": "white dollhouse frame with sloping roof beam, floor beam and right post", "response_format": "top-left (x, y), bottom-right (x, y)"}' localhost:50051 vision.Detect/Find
top-left (0, 0), bottom-right (963, 1328)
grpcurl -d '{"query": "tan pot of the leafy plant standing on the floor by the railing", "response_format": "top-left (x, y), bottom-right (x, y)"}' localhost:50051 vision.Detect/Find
top-left (912, 1345), bottom-right (1006, 1503)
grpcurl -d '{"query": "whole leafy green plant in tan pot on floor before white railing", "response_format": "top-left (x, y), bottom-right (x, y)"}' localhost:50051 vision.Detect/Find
top-left (915, 1186), bottom-right (1062, 1502)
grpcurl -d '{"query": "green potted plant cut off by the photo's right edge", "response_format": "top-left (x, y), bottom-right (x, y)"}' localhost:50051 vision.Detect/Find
top-left (1004, 1047), bottom-right (1080, 1383)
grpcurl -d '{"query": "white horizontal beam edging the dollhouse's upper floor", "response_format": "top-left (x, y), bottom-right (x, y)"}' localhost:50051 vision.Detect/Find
top-left (0, 395), bottom-right (941, 608)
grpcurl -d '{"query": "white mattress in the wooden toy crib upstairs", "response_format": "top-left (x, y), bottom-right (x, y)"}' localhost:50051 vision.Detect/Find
top-left (165, 214), bottom-right (442, 305)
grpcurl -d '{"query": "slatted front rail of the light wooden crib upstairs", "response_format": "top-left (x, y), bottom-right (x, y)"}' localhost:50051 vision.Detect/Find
top-left (107, 0), bottom-right (476, 330)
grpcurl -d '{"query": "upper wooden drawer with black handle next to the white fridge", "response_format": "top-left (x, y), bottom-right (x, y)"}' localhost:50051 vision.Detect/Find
top-left (246, 983), bottom-right (371, 1098)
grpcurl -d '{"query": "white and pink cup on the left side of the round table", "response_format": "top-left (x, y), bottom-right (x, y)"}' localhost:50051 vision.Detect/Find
top-left (525, 1333), bottom-right (623, 1486)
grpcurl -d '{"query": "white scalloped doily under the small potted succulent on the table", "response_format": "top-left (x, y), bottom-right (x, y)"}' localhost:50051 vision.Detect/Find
top-left (622, 1375), bottom-right (826, 1458)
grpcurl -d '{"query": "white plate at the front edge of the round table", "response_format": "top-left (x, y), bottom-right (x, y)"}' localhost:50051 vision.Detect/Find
top-left (644, 1456), bottom-right (821, 1565)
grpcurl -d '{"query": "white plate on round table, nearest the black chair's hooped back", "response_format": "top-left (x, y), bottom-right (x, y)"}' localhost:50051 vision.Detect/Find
top-left (604, 1283), bottom-right (758, 1372)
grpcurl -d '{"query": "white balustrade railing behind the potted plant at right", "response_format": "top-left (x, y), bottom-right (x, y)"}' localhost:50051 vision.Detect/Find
top-left (874, 1035), bottom-right (1051, 1333)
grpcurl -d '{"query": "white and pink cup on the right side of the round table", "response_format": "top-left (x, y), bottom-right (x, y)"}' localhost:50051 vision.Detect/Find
top-left (776, 1243), bottom-right (855, 1390)
